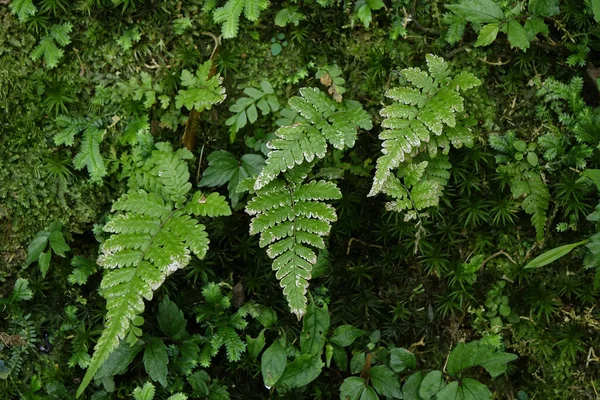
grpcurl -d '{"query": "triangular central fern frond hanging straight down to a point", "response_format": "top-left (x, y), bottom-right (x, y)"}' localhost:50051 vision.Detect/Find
top-left (246, 180), bottom-right (342, 319)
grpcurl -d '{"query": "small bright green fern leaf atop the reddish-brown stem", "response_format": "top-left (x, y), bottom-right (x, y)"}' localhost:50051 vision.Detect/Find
top-left (175, 60), bottom-right (226, 112)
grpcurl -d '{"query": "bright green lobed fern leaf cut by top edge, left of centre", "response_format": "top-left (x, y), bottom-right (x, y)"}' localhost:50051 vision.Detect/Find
top-left (213, 0), bottom-right (269, 39)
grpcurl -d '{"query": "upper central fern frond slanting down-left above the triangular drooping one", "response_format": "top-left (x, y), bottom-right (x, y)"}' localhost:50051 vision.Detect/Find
top-left (254, 88), bottom-right (372, 190)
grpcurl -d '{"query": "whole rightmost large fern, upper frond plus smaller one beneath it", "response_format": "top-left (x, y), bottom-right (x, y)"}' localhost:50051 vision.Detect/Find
top-left (369, 54), bottom-right (481, 213)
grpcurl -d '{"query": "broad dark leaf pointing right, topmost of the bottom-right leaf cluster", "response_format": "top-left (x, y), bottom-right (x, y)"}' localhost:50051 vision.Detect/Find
top-left (446, 341), bottom-right (517, 378)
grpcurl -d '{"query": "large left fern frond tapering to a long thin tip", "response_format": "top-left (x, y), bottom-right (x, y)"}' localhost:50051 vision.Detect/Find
top-left (77, 143), bottom-right (231, 396)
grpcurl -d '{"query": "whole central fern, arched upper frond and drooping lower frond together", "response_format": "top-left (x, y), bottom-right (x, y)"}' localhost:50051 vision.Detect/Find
top-left (246, 88), bottom-right (372, 319)
